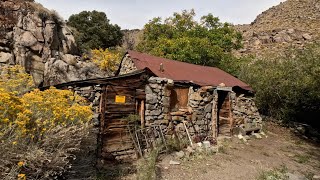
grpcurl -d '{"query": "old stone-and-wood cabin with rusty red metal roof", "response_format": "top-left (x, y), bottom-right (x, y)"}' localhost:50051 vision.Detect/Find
top-left (50, 51), bottom-right (262, 161)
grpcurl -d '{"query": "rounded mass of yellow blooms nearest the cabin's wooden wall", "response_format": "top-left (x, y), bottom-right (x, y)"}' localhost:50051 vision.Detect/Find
top-left (15, 88), bottom-right (92, 139)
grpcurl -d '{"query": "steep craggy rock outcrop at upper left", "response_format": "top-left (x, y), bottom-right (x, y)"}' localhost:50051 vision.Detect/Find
top-left (0, 0), bottom-right (108, 86)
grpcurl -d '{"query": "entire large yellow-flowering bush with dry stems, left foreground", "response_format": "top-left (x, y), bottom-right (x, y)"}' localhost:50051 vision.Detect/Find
top-left (0, 66), bottom-right (93, 180)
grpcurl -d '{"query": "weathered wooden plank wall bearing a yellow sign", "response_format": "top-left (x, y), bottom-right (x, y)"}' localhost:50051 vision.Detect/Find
top-left (98, 72), bottom-right (145, 163)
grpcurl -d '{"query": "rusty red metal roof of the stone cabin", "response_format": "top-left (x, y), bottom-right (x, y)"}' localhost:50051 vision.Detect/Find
top-left (127, 51), bottom-right (253, 91)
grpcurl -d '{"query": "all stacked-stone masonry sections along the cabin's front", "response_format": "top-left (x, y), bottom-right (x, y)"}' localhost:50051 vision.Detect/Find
top-left (70, 77), bottom-right (262, 162)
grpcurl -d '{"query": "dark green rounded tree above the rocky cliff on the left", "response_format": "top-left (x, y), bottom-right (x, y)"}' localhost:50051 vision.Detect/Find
top-left (67, 11), bottom-right (123, 52)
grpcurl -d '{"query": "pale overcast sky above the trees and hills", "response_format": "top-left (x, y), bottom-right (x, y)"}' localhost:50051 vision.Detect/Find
top-left (36, 0), bottom-right (284, 29)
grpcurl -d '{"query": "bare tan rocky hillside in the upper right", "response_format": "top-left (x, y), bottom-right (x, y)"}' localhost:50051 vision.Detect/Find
top-left (235, 0), bottom-right (320, 55)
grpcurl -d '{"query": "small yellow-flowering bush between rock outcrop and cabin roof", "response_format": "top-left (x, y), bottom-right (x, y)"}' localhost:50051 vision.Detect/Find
top-left (91, 48), bottom-right (122, 72)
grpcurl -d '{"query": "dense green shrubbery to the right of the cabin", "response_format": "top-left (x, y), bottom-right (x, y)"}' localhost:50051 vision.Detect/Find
top-left (227, 44), bottom-right (320, 129)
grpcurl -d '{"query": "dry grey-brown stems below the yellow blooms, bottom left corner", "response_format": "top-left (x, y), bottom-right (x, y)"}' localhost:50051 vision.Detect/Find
top-left (0, 125), bottom-right (91, 179)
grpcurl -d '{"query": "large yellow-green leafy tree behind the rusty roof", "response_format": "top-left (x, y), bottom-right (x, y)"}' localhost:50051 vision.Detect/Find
top-left (137, 10), bottom-right (242, 66)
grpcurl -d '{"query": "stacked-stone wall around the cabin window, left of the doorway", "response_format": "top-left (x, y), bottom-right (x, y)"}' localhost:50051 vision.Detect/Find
top-left (145, 77), bottom-right (214, 139)
